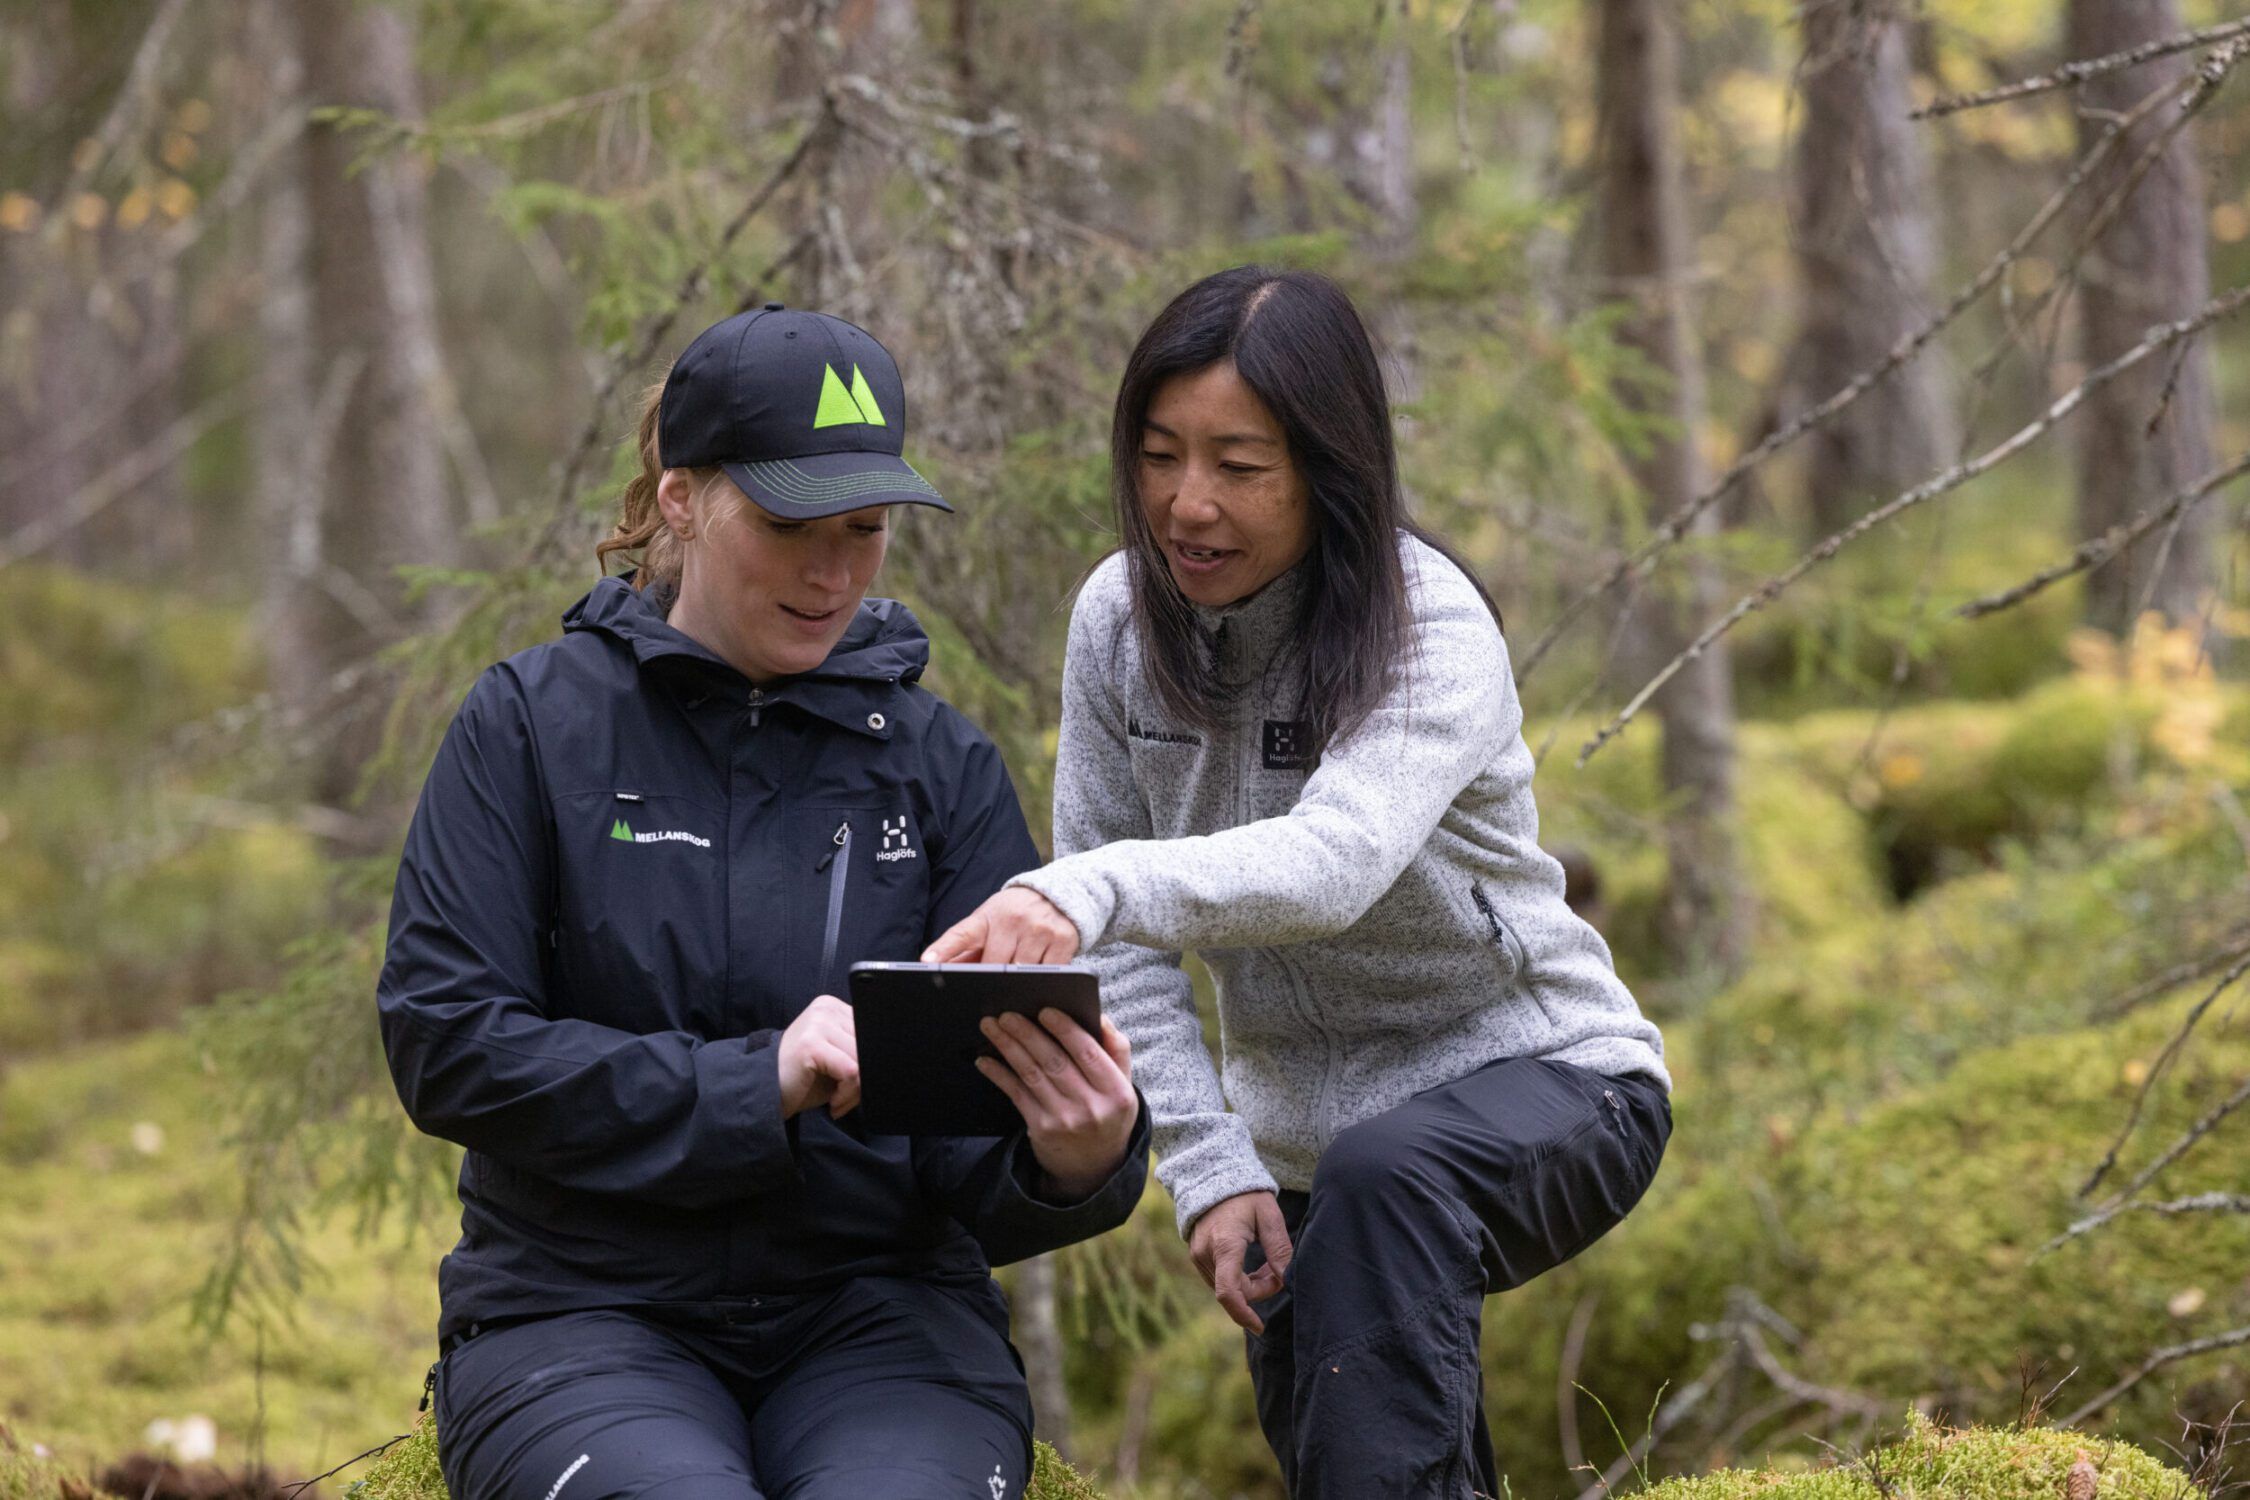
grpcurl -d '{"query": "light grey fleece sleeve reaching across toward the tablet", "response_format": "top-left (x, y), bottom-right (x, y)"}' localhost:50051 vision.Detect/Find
top-left (1017, 562), bottom-right (1523, 949)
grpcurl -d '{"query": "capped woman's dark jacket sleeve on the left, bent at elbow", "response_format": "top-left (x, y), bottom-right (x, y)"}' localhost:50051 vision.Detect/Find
top-left (376, 666), bottom-right (799, 1208)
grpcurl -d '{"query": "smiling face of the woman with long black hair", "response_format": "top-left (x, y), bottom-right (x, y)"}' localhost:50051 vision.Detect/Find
top-left (1136, 360), bottom-right (1312, 605)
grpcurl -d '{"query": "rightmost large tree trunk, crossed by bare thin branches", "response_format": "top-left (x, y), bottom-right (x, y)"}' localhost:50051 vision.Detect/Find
top-left (2066, 0), bottom-right (2216, 634)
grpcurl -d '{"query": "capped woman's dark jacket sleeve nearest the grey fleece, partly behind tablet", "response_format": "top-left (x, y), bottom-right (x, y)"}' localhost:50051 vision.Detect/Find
top-left (914, 708), bottom-right (1148, 1266)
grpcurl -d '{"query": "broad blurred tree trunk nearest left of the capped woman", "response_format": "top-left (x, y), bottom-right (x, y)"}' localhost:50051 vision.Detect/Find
top-left (257, 0), bottom-right (459, 801)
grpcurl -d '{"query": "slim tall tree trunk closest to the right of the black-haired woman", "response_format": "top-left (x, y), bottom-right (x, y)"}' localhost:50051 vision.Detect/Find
top-left (1595, 0), bottom-right (1748, 974)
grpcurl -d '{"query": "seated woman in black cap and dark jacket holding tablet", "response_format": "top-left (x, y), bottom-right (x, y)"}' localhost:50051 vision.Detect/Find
top-left (378, 306), bottom-right (1148, 1500)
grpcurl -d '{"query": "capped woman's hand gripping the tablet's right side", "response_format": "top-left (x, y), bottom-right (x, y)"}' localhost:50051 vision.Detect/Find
top-left (977, 1005), bottom-right (1141, 1203)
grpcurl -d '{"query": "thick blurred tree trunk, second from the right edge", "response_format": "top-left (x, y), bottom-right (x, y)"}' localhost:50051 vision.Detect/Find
top-left (1796, 0), bottom-right (1958, 535)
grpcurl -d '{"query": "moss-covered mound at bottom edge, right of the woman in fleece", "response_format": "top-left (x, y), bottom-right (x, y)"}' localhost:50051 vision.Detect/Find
top-left (1640, 1415), bottom-right (2194, 1500)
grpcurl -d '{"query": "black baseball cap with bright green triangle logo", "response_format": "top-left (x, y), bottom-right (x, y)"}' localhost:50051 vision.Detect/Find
top-left (657, 301), bottom-right (952, 519)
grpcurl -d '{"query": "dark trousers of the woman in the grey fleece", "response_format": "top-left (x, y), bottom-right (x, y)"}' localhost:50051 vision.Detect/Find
top-left (1247, 1057), bottom-right (1672, 1500)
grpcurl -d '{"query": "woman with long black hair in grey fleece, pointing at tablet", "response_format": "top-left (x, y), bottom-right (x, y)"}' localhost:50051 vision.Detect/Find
top-left (929, 268), bottom-right (1672, 1500)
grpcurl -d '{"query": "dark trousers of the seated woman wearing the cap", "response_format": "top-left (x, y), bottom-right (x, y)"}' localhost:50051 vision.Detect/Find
top-left (437, 1277), bottom-right (1031, 1500)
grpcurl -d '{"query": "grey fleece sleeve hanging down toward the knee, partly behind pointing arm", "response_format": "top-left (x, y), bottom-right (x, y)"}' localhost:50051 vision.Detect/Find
top-left (1022, 587), bottom-right (1276, 1235)
